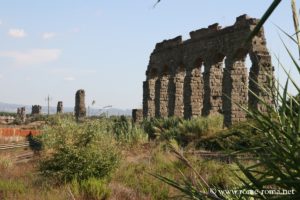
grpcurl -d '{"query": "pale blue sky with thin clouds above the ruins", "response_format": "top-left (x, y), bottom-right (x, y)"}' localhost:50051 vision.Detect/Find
top-left (0, 0), bottom-right (300, 109)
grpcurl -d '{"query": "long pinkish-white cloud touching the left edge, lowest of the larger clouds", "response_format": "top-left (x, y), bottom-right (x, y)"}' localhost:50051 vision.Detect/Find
top-left (0, 49), bottom-right (61, 66)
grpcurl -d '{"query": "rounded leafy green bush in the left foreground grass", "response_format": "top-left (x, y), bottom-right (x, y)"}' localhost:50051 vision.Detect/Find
top-left (40, 120), bottom-right (119, 183)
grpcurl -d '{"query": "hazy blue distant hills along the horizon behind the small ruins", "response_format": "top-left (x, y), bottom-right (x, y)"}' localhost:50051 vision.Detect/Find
top-left (0, 102), bottom-right (131, 116)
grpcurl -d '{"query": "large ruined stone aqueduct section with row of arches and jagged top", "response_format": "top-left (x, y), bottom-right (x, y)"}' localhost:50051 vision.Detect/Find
top-left (143, 15), bottom-right (274, 125)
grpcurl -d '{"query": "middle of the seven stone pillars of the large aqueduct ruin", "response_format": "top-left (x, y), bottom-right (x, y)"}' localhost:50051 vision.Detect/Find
top-left (184, 68), bottom-right (203, 118)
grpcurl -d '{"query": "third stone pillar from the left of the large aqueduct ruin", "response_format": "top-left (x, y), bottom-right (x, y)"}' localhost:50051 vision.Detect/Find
top-left (173, 69), bottom-right (185, 117)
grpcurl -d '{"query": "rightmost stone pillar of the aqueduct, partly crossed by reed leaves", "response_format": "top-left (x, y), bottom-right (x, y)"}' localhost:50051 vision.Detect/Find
top-left (249, 52), bottom-right (274, 112)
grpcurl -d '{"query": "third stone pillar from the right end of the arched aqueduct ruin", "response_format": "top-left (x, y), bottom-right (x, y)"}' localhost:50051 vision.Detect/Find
top-left (202, 62), bottom-right (223, 116)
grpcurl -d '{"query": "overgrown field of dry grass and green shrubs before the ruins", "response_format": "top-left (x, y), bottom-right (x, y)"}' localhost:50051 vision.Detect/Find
top-left (0, 116), bottom-right (261, 200)
